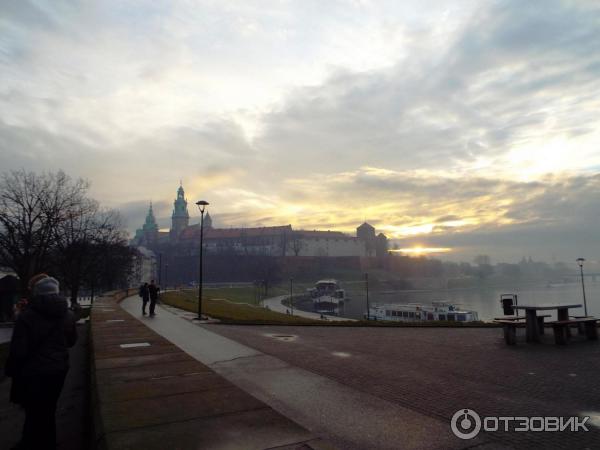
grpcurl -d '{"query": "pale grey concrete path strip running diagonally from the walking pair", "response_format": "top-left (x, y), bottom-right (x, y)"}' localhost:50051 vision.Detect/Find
top-left (121, 297), bottom-right (492, 450)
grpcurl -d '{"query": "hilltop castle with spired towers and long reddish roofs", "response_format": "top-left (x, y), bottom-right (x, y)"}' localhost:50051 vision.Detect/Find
top-left (131, 184), bottom-right (388, 257)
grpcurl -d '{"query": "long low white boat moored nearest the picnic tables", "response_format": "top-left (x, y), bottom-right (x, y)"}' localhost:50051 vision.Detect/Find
top-left (368, 302), bottom-right (479, 322)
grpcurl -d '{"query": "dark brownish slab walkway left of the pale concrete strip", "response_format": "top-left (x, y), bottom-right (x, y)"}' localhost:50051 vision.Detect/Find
top-left (92, 296), bottom-right (332, 450)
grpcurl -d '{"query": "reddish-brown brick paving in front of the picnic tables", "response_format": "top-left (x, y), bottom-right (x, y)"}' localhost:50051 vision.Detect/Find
top-left (207, 325), bottom-right (600, 449)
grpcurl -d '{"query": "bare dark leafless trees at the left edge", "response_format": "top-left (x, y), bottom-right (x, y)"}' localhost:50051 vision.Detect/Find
top-left (0, 170), bottom-right (134, 303)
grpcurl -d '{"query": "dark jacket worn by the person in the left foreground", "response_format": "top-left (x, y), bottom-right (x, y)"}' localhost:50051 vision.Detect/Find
top-left (6, 295), bottom-right (77, 377)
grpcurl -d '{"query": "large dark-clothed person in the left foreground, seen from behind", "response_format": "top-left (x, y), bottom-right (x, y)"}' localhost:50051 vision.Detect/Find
top-left (5, 276), bottom-right (77, 450)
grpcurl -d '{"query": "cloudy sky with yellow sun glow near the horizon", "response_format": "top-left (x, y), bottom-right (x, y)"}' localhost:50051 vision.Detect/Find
top-left (0, 0), bottom-right (600, 262)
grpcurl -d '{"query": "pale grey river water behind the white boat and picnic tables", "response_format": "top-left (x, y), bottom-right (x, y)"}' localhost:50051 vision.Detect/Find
top-left (341, 278), bottom-right (600, 320)
